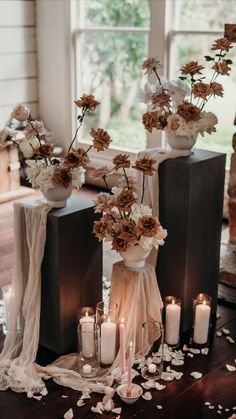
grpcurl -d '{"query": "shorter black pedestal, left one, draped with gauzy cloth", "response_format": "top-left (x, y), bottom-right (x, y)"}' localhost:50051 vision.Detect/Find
top-left (40, 197), bottom-right (102, 354)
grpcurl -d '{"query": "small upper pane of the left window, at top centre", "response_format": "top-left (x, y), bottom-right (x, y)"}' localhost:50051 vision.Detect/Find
top-left (82, 0), bottom-right (150, 27)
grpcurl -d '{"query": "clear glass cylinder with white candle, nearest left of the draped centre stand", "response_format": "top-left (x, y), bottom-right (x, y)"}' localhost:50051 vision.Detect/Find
top-left (96, 301), bottom-right (118, 367)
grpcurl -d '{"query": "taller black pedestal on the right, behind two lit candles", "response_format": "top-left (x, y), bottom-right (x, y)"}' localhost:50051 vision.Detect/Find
top-left (157, 150), bottom-right (225, 331)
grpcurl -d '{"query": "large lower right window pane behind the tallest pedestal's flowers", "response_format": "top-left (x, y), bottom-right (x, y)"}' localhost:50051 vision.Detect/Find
top-left (170, 35), bottom-right (236, 166)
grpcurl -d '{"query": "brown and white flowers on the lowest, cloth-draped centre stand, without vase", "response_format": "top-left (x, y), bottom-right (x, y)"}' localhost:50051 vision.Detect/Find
top-left (93, 154), bottom-right (167, 252)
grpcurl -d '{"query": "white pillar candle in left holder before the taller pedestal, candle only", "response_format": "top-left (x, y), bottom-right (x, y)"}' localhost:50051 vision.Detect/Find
top-left (165, 299), bottom-right (181, 345)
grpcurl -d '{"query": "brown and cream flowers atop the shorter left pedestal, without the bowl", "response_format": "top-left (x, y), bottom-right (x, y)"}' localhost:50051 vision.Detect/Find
top-left (0, 94), bottom-right (111, 191)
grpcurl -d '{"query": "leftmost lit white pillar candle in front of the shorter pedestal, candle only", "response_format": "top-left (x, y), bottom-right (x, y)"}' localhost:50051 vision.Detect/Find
top-left (79, 312), bottom-right (94, 358)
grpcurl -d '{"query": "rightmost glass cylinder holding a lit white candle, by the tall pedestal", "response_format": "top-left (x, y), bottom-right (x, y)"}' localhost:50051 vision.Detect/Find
top-left (192, 294), bottom-right (212, 346)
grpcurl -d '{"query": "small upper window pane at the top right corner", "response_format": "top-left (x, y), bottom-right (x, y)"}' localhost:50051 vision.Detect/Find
top-left (176, 0), bottom-right (236, 32)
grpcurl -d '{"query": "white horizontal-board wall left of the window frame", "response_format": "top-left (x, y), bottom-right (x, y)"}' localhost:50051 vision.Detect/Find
top-left (0, 0), bottom-right (38, 127)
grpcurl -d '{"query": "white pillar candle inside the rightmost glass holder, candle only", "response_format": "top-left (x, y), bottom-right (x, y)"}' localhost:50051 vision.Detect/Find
top-left (193, 300), bottom-right (211, 345)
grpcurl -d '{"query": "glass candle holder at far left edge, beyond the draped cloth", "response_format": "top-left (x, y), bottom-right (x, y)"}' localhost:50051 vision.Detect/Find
top-left (2, 284), bottom-right (20, 335)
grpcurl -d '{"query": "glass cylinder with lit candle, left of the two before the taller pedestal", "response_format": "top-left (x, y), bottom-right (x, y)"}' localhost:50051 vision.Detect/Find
top-left (164, 295), bottom-right (181, 348)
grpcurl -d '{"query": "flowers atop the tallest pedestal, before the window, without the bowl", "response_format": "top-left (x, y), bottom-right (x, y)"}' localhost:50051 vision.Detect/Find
top-left (142, 38), bottom-right (232, 136)
